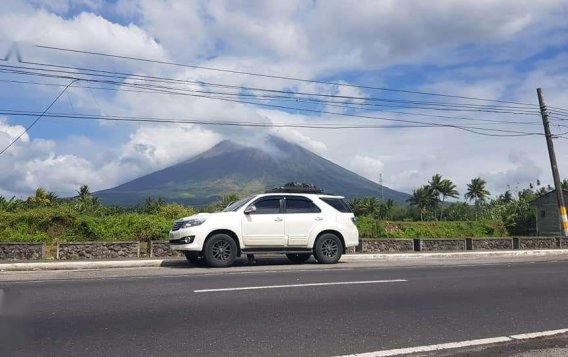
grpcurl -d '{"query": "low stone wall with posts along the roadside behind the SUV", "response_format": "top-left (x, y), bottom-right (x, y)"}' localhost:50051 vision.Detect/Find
top-left (0, 237), bottom-right (568, 260)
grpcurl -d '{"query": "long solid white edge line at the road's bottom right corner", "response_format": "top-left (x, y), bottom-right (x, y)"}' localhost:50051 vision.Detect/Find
top-left (340, 329), bottom-right (568, 357)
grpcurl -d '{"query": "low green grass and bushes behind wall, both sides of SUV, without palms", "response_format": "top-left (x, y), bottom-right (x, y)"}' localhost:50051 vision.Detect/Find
top-left (0, 204), bottom-right (507, 244)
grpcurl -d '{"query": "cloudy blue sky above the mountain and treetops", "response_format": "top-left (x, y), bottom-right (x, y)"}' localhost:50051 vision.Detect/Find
top-left (0, 0), bottom-right (568, 197)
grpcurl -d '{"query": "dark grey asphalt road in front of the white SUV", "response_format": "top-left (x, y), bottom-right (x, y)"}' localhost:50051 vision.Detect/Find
top-left (0, 261), bottom-right (568, 356)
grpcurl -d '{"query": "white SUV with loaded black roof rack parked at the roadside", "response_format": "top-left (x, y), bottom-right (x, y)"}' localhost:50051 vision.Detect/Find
top-left (169, 193), bottom-right (359, 267)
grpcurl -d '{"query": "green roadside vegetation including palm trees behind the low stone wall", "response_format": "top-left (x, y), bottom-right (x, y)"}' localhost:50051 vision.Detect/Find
top-left (0, 174), bottom-right (568, 244)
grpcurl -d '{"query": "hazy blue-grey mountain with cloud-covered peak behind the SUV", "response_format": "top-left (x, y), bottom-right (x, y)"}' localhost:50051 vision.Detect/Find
top-left (95, 136), bottom-right (408, 205)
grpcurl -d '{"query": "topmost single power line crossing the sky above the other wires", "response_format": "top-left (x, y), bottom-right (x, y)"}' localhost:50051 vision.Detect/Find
top-left (34, 45), bottom-right (536, 107)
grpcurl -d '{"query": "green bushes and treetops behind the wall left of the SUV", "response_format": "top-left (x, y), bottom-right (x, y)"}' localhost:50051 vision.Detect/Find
top-left (0, 191), bottom-right (194, 244)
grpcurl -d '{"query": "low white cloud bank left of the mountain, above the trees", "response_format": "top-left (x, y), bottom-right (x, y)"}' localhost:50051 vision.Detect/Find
top-left (0, 119), bottom-right (221, 197)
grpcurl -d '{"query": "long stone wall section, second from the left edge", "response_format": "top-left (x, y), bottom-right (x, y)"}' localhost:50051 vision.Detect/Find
top-left (57, 242), bottom-right (140, 260)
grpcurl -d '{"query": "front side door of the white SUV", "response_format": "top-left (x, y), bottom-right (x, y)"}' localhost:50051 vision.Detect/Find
top-left (242, 196), bottom-right (286, 247)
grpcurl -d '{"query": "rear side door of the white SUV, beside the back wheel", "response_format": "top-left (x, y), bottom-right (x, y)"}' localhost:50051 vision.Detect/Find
top-left (284, 196), bottom-right (323, 247)
